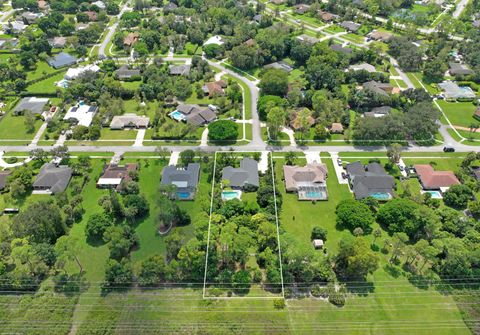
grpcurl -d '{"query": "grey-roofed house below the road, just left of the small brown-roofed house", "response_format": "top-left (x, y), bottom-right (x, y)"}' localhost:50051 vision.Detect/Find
top-left (33, 163), bottom-right (72, 194)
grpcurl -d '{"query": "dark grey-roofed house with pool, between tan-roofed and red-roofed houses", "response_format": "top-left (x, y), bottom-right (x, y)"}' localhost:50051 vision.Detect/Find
top-left (346, 161), bottom-right (395, 201)
